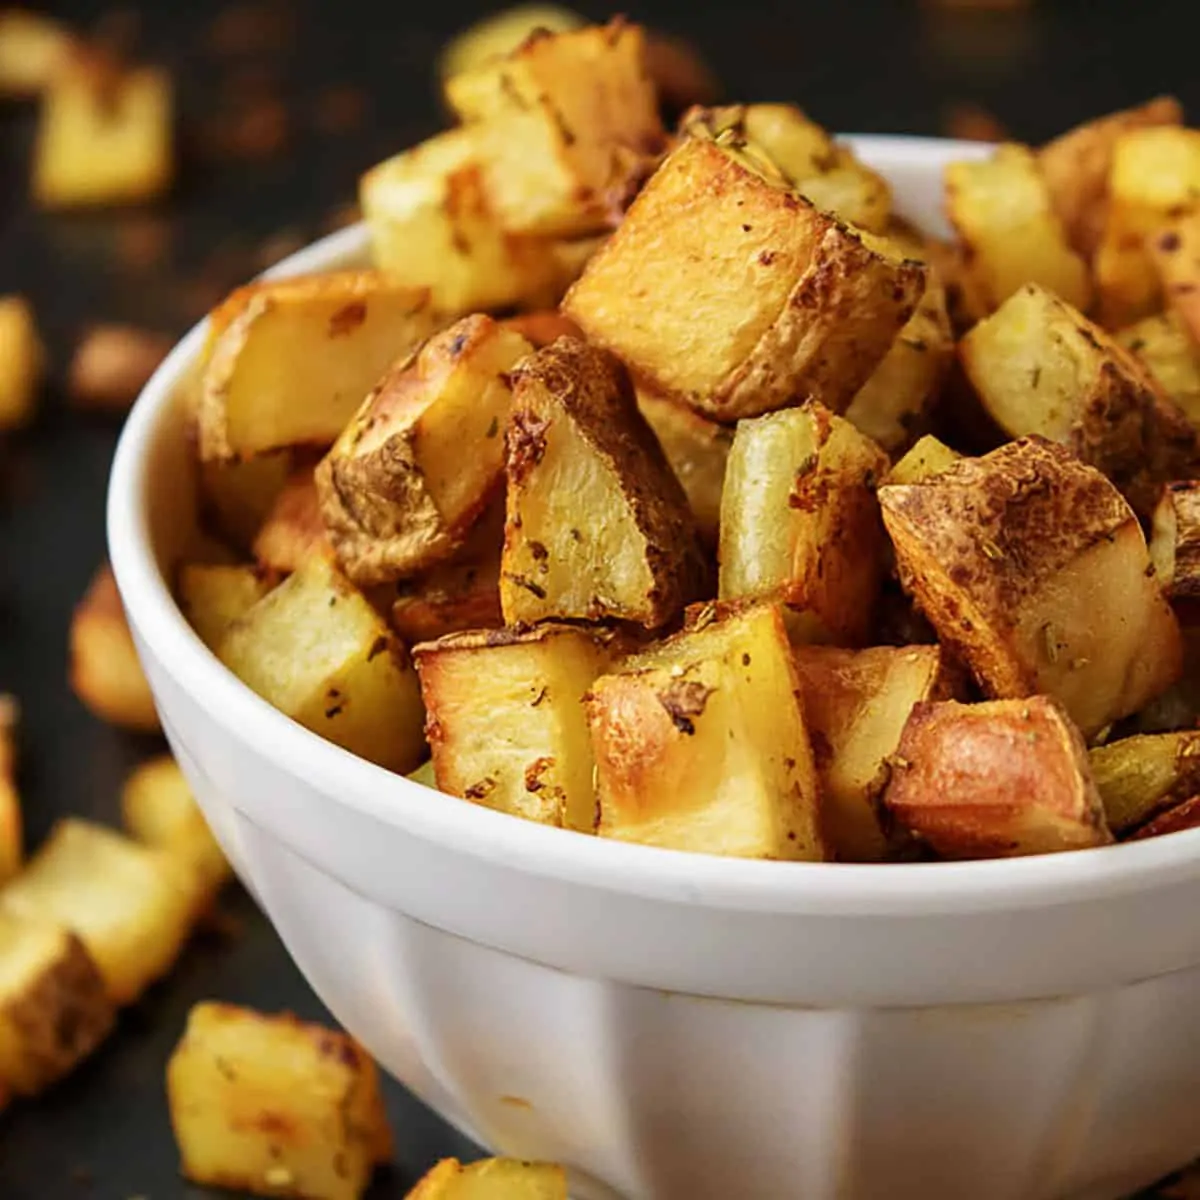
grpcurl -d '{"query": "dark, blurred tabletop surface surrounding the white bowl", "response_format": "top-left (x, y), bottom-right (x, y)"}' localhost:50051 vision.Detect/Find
top-left (0, 0), bottom-right (1200, 1200)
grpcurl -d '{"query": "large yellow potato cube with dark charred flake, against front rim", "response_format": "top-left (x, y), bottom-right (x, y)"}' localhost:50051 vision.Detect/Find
top-left (587, 605), bottom-right (824, 859)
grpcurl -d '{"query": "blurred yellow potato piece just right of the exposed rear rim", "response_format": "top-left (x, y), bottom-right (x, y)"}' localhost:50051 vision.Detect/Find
top-left (946, 144), bottom-right (1092, 311)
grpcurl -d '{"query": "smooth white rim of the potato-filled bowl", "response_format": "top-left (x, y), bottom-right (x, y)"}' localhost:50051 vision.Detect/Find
top-left (107, 134), bottom-right (1200, 917)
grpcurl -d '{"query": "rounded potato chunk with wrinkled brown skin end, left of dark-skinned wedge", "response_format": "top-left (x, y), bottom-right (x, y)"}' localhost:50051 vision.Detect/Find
top-left (317, 314), bottom-right (532, 584)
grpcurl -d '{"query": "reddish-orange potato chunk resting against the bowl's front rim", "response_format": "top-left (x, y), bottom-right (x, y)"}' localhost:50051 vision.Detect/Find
top-left (883, 696), bottom-right (1112, 858)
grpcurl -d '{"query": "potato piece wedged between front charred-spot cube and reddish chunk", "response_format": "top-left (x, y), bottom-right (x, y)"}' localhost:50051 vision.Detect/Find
top-left (794, 646), bottom-right (958, 863)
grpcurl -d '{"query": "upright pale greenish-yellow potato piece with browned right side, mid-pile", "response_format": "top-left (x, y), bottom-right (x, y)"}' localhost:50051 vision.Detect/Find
top-left (720, 403), bottom-right (888, 644)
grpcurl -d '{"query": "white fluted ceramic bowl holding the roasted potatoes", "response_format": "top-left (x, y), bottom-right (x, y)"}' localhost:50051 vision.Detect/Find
top-left (108, 138), bottom-right (1200, 1200)
